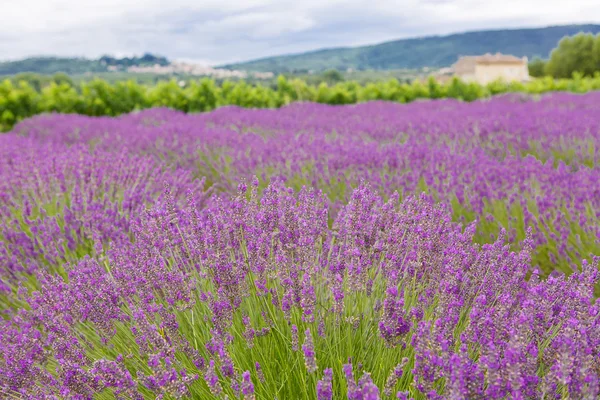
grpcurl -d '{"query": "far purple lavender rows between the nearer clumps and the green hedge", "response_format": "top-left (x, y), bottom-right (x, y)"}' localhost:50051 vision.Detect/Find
top-left (8, 92), bottom-right (600, 272)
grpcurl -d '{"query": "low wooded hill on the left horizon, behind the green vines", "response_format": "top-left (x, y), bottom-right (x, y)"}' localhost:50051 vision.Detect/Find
top-left (0, 53), bottom-right (169, 75)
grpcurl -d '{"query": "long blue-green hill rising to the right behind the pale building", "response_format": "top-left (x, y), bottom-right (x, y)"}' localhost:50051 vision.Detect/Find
top-left (218, 24), bottom-right (600, 73)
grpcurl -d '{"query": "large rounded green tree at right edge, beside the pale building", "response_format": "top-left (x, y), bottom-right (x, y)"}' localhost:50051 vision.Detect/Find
top-left (545, 33), bottom-right (599, 78)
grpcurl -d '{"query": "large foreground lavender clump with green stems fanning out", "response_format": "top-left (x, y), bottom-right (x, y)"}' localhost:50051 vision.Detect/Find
top-left (0, 182), bottom-right (600, 400)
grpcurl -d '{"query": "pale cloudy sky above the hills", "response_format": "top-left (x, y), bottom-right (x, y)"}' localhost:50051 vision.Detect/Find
top-left (0, 0), bottom-right (600, 65)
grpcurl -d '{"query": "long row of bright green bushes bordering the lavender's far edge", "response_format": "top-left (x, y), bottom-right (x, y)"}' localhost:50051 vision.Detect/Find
top-left (0, 74), bottom-right (600, 131)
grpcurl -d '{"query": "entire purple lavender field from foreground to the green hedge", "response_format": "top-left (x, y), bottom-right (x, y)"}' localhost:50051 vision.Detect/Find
top-left (0, 92), bottom-right (600, 400)
